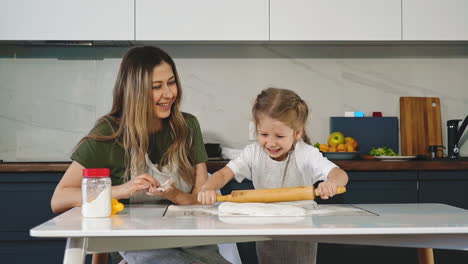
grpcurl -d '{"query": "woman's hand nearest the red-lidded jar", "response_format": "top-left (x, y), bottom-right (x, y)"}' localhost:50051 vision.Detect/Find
top-left (112, 173), bottom-right (159, 199)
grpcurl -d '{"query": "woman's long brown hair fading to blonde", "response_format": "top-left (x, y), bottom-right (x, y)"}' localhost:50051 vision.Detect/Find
top-left (78, 46), bottom-right (195, 184)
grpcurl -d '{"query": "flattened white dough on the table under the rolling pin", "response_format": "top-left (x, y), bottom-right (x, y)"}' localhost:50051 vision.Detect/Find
top-left (218, 202), bottom-right (307, 216)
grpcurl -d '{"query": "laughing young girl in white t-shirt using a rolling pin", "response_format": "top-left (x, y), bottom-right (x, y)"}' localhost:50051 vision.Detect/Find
top-left (198, 88), bottom-right (348, 263)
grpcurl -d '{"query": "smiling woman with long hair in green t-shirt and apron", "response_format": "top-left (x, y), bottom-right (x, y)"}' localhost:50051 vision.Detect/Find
top-left (51, 47), bottom-right (227, 263)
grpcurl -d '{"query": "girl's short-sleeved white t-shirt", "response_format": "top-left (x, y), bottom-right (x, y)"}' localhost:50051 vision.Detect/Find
top-left (227, 141), bottom-right (337, 189)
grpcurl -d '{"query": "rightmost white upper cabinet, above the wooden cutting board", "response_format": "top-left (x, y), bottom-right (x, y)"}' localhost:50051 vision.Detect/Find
top-left (403, 0), bottom-right (468, 40)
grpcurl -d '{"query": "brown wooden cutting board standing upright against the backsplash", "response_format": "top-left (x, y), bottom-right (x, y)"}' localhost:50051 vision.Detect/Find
top-left (400, 97), bottom-right (442, 156)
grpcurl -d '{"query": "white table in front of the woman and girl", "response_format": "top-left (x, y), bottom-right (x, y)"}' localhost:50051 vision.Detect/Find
top-left (30, 204), bottom-right (468, 263)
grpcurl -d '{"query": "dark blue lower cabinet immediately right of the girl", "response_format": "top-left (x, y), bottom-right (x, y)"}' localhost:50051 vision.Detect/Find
top-left (317, 171), bottom-right (418, 264)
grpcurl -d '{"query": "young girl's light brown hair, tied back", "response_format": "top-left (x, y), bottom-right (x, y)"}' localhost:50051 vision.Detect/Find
top-left (252, 88), bottom-right (311, 144)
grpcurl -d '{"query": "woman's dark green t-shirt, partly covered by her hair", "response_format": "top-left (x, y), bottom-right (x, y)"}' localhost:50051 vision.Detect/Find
top-left (71, 113), bottom-right (208, 185)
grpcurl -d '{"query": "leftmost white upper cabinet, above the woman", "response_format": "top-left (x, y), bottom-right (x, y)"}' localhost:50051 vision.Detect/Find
top-left (0, 0), bottom-right (134, 40)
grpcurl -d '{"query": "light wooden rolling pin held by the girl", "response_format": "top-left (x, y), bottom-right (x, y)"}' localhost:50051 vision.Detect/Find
top-left (216, 186), bottom-right (346, 203)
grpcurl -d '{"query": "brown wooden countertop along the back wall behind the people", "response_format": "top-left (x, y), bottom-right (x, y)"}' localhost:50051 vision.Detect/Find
top-left (0, 160), bottom-right (468, 172)
